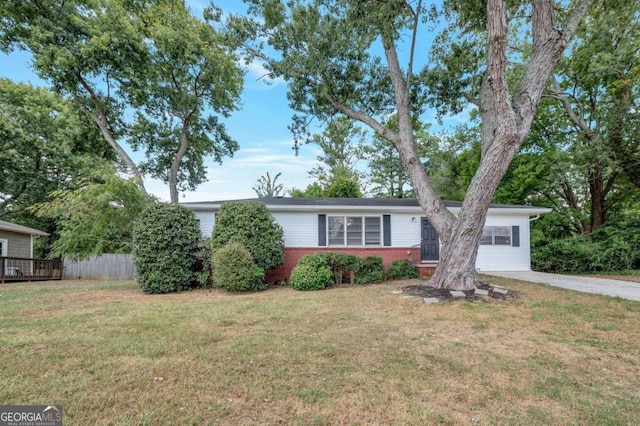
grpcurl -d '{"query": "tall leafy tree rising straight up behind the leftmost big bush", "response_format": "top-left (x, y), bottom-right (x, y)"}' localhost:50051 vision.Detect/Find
top-left (128, 1), bottom-right (243, 203)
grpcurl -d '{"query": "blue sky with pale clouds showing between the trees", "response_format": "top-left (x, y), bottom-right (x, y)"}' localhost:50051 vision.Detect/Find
top-left (0, 0), bottom-right (458, 202)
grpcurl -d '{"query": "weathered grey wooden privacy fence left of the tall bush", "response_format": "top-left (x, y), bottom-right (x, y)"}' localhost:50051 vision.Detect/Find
top-left (63, 254), bottom-right (136, 280)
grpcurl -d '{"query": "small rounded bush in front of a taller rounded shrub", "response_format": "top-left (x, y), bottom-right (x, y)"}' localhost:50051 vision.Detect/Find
top-left (211, 241), bottom-right (264, 291)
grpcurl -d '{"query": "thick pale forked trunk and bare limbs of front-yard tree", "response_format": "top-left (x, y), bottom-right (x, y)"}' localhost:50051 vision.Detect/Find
top-left (325, 0), bottom-right (594, 290)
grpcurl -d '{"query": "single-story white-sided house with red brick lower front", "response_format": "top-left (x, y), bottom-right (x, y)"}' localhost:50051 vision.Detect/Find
top-left (184, 197), bottom-right (551, 281)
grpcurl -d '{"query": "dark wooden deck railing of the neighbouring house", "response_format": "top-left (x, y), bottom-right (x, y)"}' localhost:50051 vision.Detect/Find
top-left (0, 257), bottom-right (63, 283)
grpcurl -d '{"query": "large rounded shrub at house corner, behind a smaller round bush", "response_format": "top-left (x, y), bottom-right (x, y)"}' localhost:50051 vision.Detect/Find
top-left (211, 201), bottom-right (284, 271)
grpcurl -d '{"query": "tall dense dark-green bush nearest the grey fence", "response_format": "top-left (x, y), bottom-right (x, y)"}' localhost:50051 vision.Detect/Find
top-left (133, 203), bottom-right (200, 294)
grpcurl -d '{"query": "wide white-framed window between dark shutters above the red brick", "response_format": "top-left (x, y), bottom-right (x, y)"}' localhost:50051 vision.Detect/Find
top-left (327, 216), bottom-right (382, 246)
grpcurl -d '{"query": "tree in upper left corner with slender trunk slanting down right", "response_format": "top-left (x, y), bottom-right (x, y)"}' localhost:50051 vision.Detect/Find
top-left (0, 0), bottom-right (147, 189)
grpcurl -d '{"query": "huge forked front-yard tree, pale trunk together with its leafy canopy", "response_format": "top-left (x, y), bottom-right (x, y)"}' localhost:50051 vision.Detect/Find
top-left (241, 0), bottom-right (593, 290)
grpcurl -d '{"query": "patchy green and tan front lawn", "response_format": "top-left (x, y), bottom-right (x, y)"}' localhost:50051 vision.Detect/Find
top-left (0, 278), bottom-right (640, 425)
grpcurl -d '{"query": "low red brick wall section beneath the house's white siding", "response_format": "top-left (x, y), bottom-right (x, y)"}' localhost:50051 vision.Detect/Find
top-left (265, 247), bottom-right (424, 283)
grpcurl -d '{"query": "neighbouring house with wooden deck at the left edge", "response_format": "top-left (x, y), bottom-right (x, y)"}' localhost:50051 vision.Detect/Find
top-left (0, 220), bottom-right (62, 283)
